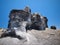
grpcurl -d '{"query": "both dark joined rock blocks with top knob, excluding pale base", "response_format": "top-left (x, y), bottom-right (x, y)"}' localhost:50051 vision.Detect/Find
top-left (8, 7), bottom-right (48, 30)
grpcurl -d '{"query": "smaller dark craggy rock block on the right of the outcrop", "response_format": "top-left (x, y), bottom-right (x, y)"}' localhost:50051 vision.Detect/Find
top-left (31, 14), bottom-right (48, 30)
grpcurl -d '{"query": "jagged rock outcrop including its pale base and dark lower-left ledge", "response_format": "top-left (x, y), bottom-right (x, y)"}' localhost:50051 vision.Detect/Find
top-left (1, 7), bottom-right (48, 43)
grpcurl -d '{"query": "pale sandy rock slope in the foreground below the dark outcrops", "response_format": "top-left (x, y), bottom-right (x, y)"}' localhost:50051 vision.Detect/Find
top-left (0, 29), bottom-right (60, 45)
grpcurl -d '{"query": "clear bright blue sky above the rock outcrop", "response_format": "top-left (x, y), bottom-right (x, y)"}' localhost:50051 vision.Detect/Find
top-left (0, 0), bottom-right (60, 29)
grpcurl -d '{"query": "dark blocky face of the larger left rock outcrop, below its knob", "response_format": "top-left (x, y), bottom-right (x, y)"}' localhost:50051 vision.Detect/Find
top-left (8, 10), bottom-right (29, 28)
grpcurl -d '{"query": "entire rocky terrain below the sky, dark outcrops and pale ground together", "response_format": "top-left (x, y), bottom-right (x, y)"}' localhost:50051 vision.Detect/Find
top-left (0, 7), bottom-right (60, 45)
